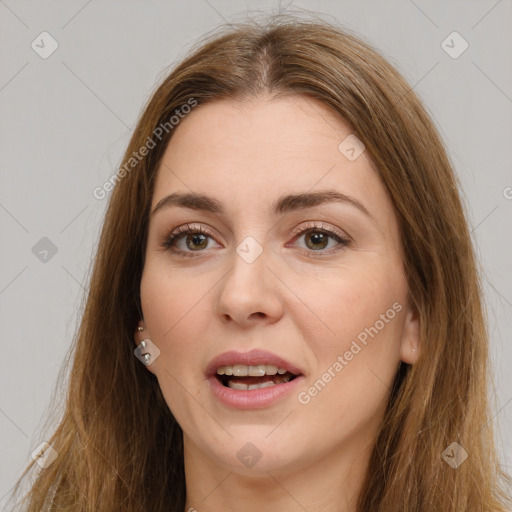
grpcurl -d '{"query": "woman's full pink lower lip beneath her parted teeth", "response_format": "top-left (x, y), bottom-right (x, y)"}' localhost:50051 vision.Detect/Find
top-left (208, 375), bottom-right (304, 409)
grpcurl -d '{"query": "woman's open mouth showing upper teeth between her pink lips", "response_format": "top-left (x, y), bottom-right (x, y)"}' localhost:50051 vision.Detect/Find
top-left (216, 365), bottom-right (297, 391)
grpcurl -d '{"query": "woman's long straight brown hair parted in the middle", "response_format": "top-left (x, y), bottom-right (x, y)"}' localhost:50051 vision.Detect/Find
top-left (10, 12), bottom-right (510, 512)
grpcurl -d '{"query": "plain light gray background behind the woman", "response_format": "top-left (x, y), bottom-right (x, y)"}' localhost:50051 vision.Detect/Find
top-left (0, 0), bottom-right (512, 507)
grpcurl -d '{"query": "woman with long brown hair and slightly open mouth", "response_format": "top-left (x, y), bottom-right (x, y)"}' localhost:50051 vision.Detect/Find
top-left (12, 17), bottom-right (510, 512)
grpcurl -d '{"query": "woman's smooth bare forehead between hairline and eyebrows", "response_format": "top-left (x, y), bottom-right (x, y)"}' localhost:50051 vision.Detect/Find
top-left (152, 96), bottom-right (390, 222)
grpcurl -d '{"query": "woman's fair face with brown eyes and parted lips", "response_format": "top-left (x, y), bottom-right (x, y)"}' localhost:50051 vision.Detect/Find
top-left (136, 97), bottom-right (418, 474)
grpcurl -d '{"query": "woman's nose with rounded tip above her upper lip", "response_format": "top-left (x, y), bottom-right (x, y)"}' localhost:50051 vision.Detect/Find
top-left (215, 240), bottom-right (285, 327)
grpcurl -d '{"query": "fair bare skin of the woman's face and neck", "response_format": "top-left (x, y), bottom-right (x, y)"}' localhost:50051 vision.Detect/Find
top-left (135, 96), bottom-right (420, 512)
